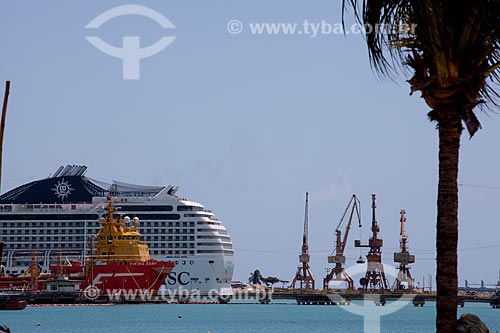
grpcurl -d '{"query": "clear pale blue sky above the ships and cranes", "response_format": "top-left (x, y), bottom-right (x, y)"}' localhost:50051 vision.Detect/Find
top-left (0, 0), bottom-right (500, 286)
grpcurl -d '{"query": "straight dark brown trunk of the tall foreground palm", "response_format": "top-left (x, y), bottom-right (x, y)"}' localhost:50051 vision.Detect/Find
top-left (436, 110), bottom-right (462, 333)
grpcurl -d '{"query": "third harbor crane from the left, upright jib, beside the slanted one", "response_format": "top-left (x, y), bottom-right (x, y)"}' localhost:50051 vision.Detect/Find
top-left (354, 194), bottom-right (388, 291)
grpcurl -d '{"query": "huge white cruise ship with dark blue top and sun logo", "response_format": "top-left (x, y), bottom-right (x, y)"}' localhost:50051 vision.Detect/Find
top-left (0, 165), bottom-right (234, 295)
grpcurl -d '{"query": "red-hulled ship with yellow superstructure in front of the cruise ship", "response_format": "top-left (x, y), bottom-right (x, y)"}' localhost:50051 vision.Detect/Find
top-left (0, 198), bottom-right (175, 299)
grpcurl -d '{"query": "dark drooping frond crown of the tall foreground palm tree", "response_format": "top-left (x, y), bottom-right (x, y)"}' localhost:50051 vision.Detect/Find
top-left (342, 0), bottom-right (500, 136)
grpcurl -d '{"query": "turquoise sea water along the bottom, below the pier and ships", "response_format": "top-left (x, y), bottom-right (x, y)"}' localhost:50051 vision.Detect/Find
top-left (0, 301), bottom-right (500, 333)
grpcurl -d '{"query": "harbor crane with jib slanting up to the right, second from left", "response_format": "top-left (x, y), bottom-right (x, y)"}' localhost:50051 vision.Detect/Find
top-left (323, 194), bottom-right (361, 289)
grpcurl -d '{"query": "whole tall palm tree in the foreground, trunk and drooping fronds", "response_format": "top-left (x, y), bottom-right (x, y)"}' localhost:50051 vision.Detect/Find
top-left (342, 0), bottom-right (500, 332)
